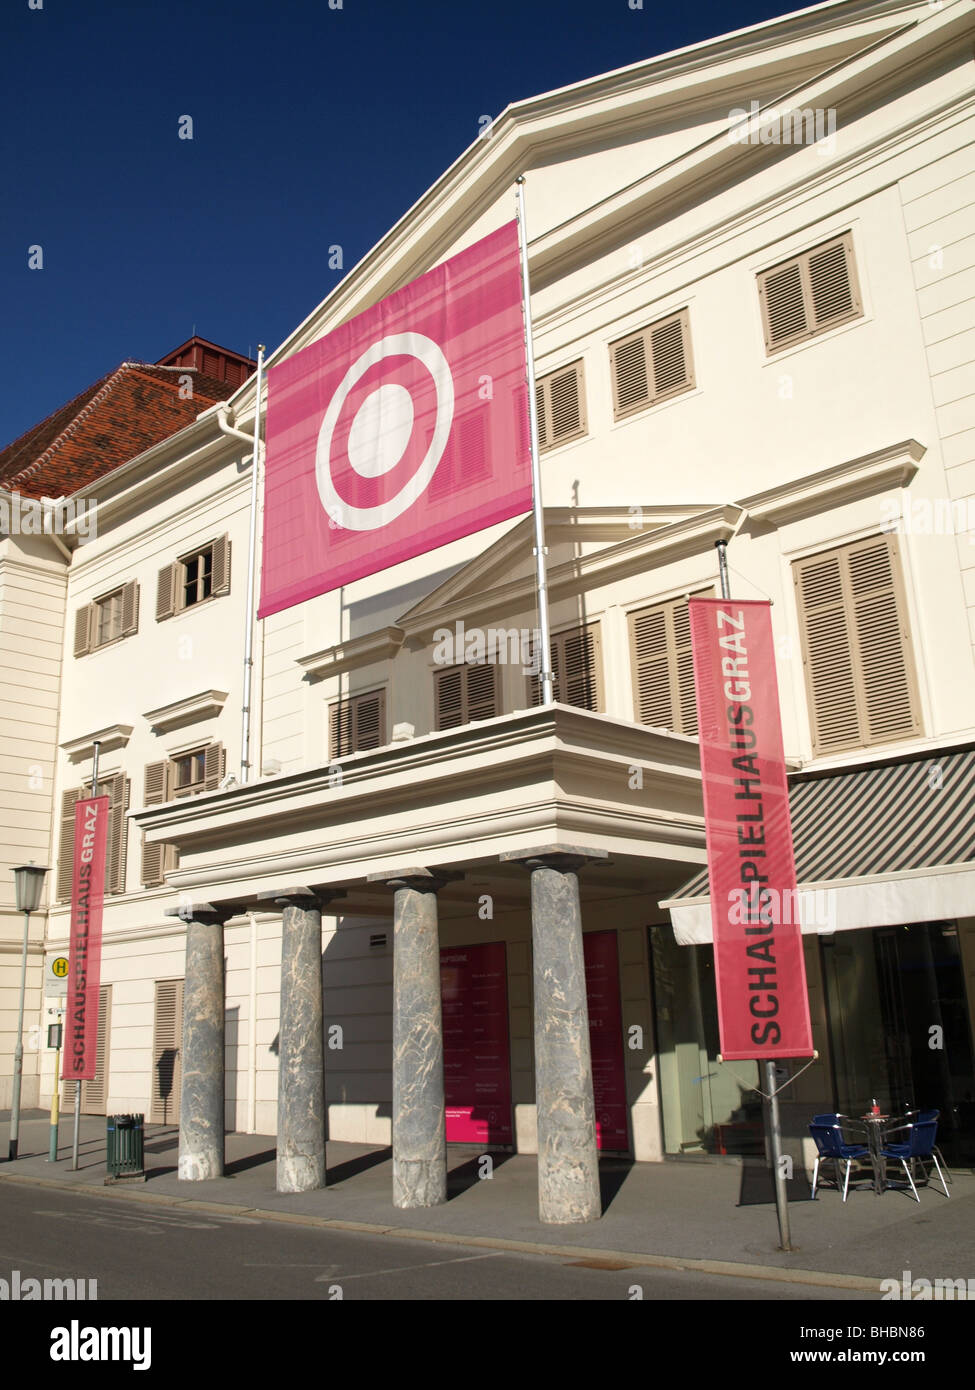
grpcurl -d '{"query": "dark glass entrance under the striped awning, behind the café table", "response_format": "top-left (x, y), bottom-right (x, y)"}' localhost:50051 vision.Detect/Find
top-left (821, 922), bottom-right (975, 1163)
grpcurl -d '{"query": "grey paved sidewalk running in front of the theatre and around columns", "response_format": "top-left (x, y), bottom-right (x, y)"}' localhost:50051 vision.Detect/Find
top-left (0, 1111), bottom-right (975, 1295)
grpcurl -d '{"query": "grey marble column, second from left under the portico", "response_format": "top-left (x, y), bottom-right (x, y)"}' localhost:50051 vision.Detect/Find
top-left (257, 887), bottom-right (345, 1193)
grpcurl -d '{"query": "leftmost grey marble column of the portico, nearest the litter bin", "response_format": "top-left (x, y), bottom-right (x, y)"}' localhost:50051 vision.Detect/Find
top-left (167, 902), bottom-right (242, 1183)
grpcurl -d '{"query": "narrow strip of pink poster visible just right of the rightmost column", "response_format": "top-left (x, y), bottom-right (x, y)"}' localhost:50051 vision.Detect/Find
top-left (583, 931), bottom-right (630, 1150)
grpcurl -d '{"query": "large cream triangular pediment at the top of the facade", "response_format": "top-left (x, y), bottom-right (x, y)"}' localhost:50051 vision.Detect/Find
top-left (221, 0), bottom-right (951, 414)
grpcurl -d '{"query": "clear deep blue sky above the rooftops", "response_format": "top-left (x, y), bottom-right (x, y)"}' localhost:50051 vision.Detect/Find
top-left (0, 0), bottom-right (800, 445)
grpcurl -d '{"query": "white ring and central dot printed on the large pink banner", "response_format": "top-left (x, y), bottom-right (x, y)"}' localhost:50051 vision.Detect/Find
top-left (314, 334), bottom-right (453, 531)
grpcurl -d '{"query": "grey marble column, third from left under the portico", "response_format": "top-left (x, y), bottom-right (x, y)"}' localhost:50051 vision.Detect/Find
top-left (370, 869), bottom-right (462, 1207)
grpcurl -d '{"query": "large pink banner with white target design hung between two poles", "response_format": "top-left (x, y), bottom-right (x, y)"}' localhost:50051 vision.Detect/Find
top-left (259, 222), bottom-right (531, 617)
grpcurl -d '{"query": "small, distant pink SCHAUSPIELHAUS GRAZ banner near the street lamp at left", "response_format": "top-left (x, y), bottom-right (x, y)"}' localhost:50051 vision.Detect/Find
top-left (61, 796), bottom-right (108, 1081)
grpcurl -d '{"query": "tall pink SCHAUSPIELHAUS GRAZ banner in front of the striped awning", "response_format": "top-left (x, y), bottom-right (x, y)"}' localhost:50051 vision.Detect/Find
top-left (690, 599), bottom-right (812, 1061)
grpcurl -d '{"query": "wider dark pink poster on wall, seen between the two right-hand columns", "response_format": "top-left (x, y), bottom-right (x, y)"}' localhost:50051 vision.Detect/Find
top-left (440, 941), bottom-right (512, 1144)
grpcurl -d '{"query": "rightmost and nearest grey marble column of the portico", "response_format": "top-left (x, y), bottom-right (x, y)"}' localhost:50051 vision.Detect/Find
top-left (501, 845), bottom-right (606, 1225)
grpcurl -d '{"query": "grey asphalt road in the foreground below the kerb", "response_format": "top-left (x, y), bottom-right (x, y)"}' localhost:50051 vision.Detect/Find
top-left (0, 1183), bottom-right (878, 1316)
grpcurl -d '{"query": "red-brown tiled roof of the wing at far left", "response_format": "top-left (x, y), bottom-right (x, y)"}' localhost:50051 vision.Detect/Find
top-left (0, 361), bottom-right (231, 498)
